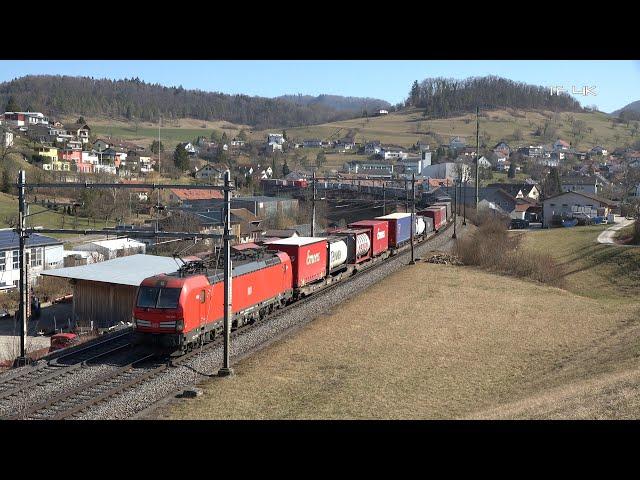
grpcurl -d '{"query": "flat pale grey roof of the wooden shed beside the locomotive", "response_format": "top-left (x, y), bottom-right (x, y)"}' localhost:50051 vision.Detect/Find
top-left (41, 254), bottom-right (179, 286)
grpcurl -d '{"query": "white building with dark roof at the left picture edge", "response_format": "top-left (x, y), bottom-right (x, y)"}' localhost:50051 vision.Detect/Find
top-left (0, 231), bottom-right (64, 290)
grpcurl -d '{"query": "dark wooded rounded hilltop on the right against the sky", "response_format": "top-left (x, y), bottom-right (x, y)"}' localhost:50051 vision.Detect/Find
top-left (407, 76), bottom-right (582, 118)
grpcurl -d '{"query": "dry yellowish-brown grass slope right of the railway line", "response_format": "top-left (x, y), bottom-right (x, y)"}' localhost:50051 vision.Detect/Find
top-left (154, 226), bottom-right (640, 419)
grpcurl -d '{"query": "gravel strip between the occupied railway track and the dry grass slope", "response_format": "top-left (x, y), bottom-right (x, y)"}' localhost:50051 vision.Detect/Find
top-left (75, 220), bottom-right (464, 420)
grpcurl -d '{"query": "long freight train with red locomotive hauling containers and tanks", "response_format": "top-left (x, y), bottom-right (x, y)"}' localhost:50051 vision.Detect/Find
top-left (133, 206), bottom-right (450, 355)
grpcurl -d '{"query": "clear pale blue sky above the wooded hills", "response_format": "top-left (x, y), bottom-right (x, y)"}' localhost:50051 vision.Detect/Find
top-left (0, 60), bottom-right (640, 112)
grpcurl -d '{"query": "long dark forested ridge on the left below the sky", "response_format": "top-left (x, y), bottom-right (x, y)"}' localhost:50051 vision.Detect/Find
top-left (0, 75), bottom-right (362, 129)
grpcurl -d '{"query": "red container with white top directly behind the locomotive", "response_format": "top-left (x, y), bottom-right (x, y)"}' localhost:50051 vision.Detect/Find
top-left (266, 237), bottom-right (327, 287)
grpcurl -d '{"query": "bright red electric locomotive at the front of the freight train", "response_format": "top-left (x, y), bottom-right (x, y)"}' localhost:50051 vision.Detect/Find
top-left (133, 252), bottom-right (293, 352)
